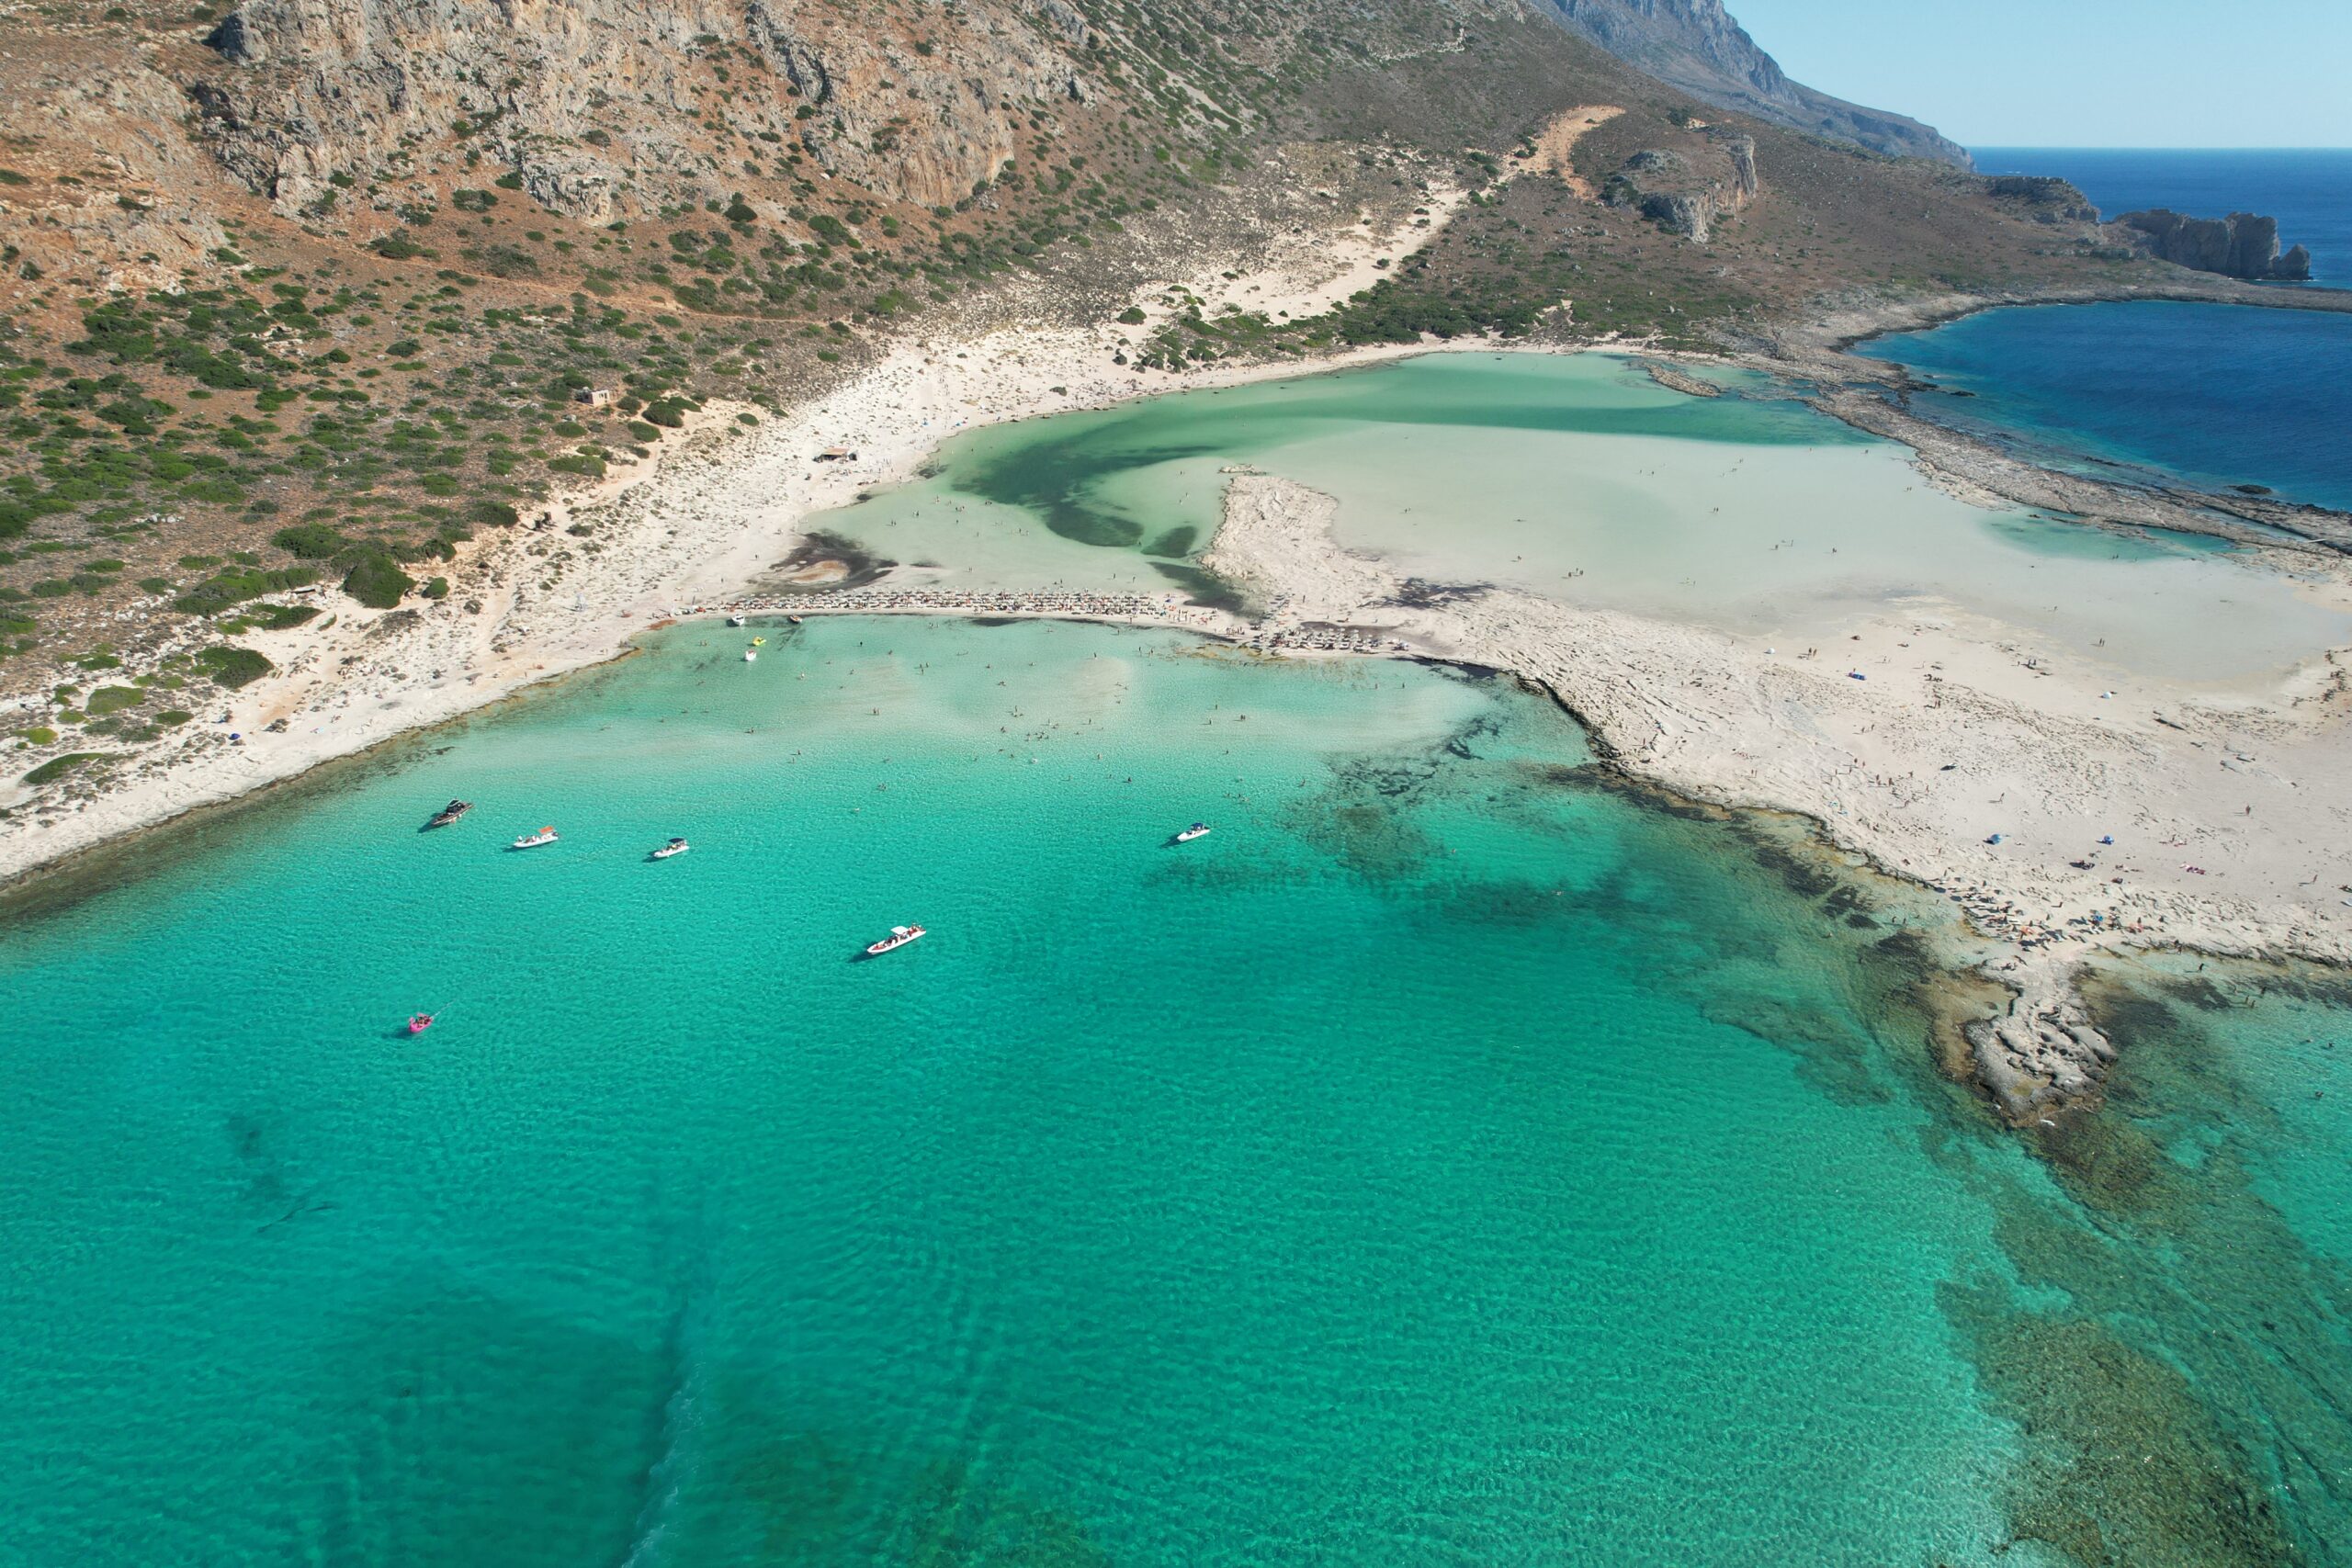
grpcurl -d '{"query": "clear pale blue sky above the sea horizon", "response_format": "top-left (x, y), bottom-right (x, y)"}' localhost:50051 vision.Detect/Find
top-left (1724, 0), bottom-right (2352, 148)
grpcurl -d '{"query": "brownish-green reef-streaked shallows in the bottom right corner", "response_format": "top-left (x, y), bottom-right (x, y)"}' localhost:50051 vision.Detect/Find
top-left (1945, 959), bottom-right (2352, 1568)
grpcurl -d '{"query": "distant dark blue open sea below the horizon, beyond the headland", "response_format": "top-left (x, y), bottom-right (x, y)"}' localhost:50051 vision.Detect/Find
top-left (1975, 148), bottom-right (2352, 285)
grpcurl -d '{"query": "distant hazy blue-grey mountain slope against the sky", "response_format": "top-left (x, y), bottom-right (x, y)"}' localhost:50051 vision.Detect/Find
top-left (1541, 0), bottom-right (1969, 169)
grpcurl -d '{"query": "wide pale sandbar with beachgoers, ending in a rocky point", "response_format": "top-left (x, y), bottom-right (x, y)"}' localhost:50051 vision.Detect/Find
top-left (1209, 475), bottom-right (2352, 1119)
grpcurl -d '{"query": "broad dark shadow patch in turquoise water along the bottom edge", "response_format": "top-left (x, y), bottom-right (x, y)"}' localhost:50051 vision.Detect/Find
top-left (287, 1274), bottom-right (1113, 1568)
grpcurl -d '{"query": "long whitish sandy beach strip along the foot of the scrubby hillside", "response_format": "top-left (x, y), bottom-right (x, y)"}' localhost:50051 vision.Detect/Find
top-left (0, 184), bottom-right (1463, 882)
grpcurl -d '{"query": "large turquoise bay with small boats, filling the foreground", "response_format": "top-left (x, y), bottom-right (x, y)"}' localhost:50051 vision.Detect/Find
top-left (0, 621), bottom-right (2352, 1568)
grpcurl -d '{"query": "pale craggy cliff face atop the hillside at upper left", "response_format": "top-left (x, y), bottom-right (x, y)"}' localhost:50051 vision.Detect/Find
top-left (190, 0), bottom-right (1091, 221)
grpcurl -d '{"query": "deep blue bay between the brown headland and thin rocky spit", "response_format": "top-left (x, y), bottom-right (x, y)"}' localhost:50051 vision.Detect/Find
top-left (1856, 301), bottom-right (2352, 522)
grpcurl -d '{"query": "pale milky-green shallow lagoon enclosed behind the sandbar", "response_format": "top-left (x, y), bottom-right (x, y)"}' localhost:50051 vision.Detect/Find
top-left (820, 355), bottom-right (2352, 680)
